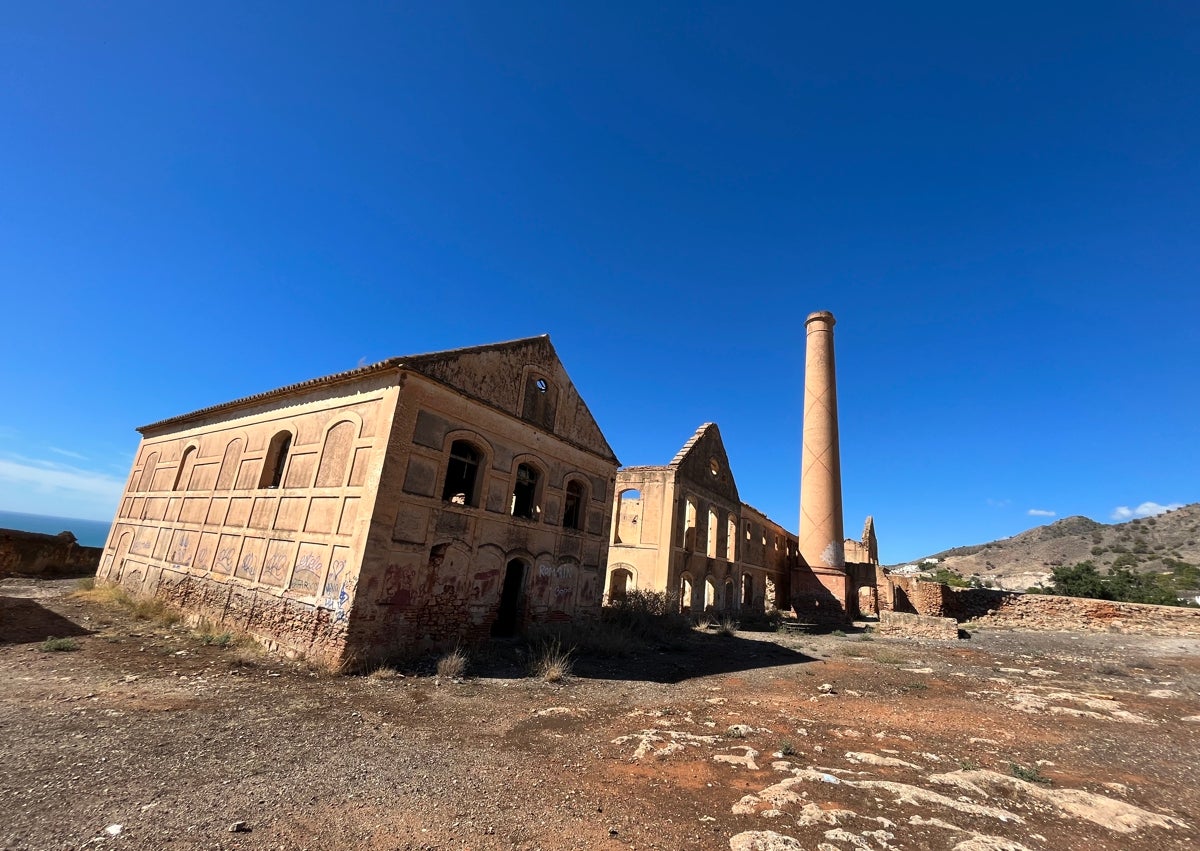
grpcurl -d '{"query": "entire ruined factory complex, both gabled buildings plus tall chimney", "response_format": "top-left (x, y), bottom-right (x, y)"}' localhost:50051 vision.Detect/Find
top-left (97, 313), bottom-right (878, 666)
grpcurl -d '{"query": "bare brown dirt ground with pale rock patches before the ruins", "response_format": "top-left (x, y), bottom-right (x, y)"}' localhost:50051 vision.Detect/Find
top-left (0, 580), bottom-right (1200, 851)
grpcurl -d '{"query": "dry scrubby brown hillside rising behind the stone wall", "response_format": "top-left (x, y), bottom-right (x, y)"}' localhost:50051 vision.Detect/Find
top-left (902, 503), bottom-right (1200, 591)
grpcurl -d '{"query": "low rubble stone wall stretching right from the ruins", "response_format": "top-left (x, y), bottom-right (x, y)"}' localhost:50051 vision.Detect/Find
top-left (889, 576), bottom-right (1200, 636)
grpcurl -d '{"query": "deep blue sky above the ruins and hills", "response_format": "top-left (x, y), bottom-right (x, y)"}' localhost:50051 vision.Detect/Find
top-left (0, 6), bottom-right (1200, 563)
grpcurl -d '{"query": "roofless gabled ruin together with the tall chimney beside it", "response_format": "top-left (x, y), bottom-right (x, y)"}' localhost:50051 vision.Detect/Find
top-left (606, 311), bottom-right (880, 624)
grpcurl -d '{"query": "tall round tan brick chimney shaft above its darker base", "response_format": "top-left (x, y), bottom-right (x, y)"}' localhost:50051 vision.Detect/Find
top-left (800, 311), bottom-right (846, 570)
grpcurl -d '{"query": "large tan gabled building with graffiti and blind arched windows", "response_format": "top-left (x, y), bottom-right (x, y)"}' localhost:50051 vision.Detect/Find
top-left (97, 336), bottom-right (617, 666)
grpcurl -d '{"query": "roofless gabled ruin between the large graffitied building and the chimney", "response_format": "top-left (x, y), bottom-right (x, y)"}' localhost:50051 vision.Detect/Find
top-left (606, 422), bottom-right (802, 615)
